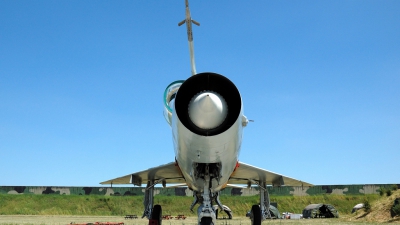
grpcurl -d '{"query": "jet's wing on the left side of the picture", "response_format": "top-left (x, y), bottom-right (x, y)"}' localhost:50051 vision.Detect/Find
top-left (100, 162), bottom-right (185, 186)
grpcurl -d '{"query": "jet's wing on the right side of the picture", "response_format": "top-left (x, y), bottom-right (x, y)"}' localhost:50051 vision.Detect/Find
top-left (228, 162), bottom-right (313, 186)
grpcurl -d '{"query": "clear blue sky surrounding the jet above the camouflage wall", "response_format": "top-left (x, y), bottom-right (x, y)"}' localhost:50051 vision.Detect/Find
top-left (0, 0), bottom-right (400, 186)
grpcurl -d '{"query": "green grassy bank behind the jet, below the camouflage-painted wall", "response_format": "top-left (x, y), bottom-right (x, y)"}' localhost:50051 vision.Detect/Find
top-left (0, 194), bottom-right (383, 216)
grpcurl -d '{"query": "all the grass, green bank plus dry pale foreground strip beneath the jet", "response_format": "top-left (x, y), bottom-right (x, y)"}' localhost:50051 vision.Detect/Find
top-left (0, 190), bottom-right (400, 225)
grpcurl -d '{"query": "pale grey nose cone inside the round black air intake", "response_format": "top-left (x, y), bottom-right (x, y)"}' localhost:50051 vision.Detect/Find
top-left (188, 91), bottom-right (228, 129)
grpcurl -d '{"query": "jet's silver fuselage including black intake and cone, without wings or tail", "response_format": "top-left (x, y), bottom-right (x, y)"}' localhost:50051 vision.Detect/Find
top-left (162, 73), bottom-right (247, 192)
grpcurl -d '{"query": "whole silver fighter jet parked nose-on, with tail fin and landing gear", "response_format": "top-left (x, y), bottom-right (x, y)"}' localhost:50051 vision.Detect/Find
top-left (101, 0), bottom-right (312, 225)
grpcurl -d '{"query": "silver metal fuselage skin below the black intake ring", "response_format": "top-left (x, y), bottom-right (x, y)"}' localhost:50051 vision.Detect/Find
top-left (172, 105), bottom-right (243, 192)
